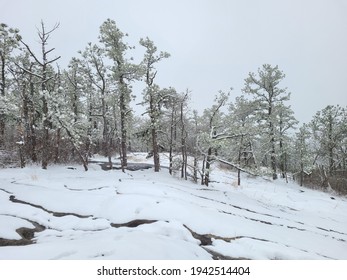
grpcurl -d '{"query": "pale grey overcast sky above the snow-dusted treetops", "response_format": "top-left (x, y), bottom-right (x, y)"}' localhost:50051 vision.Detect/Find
top-left (0, 0), bottom-right (347, 122)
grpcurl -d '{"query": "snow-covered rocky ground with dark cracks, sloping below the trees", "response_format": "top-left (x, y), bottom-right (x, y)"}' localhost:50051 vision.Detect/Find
top-left (0, 154), bottom-right (347, 260)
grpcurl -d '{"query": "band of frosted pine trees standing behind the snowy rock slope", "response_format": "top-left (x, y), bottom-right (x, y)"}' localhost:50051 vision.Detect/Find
top-left (0, 19), bottom-right (347, 194)
